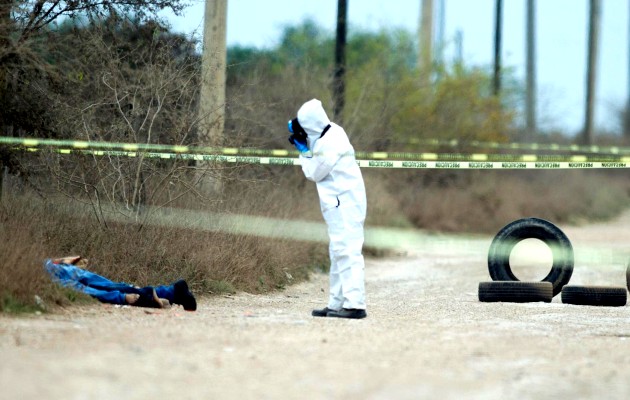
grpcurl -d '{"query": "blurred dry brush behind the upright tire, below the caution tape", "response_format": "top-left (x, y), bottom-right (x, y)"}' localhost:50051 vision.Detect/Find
top-left (398, 170), bottom-right (630, 233)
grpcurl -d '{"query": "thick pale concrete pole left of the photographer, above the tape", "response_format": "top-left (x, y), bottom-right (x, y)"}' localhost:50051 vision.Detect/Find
top-left (199, 0), bottom-right (227, 146)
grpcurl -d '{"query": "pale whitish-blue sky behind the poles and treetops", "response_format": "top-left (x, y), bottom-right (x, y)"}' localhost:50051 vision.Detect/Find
top-left (168, 0), bottom-right (630, 134)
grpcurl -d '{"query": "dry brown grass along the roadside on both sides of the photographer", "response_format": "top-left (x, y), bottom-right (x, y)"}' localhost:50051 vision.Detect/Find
top-left (0, 161), bottom-right (630, 312)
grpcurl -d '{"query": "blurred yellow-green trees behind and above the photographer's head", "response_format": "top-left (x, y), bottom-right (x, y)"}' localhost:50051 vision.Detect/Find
top-left (228, 21), bottom-right (518, 150)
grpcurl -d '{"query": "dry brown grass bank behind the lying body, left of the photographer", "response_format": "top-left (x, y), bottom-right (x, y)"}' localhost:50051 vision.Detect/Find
top-left (0, 179), bottom-right (327, 311)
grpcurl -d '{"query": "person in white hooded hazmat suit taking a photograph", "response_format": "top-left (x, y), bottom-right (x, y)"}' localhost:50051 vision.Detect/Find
top-left (289, 99), bottom-right (367, 319)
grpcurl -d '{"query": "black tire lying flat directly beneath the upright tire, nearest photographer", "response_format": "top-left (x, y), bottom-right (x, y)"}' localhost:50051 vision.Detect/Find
top-left (479, 281), bottom-right (553, 303)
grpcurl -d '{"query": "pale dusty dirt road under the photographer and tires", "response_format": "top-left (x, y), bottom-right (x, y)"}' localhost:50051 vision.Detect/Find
top-left (0, 215), bottom-right (630, 400)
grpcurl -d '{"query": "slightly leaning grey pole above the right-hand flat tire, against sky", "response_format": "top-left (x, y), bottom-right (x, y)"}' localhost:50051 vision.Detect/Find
top-left (583, 0), bottom-right (602, 145)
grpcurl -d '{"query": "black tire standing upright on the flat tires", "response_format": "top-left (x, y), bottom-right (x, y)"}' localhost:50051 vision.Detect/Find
top-left (488, 218), bottom-right (573, 296)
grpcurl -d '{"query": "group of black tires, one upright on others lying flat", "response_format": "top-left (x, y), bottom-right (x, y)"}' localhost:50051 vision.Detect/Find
top-left (479, 218), bottom-right (630, 307)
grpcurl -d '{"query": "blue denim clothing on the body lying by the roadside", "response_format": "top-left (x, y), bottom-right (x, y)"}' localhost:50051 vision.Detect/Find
top-left (44, 259), bottom-right (175, 304)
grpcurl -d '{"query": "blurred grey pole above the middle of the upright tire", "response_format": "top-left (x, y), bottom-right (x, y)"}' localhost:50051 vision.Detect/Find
top-left (525, 0), bottom-right (537, 141)
